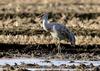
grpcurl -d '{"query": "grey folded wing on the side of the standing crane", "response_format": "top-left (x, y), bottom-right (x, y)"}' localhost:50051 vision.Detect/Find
top-left (53, 25), bottom-right (75, 44)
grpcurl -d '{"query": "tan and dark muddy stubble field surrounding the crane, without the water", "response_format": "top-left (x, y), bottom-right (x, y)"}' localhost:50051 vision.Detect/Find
top-left (0, 0), bottom-right (100, 71)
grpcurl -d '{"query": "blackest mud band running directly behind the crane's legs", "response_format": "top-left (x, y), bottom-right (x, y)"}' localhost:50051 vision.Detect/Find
top-left (0, 43), bottom-right (100, 54)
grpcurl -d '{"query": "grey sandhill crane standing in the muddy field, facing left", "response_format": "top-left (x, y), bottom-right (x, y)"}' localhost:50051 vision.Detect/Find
top-left (42, 13), bottom-right (75, 53)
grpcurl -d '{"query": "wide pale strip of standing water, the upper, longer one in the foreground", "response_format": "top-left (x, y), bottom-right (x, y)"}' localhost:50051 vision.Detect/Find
top-left (0, 58), bottom-right (100, 66)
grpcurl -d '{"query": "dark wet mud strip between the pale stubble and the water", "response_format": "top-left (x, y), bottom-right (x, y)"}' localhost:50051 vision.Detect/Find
top-left (0, 44), bottom-right (100, 60)
